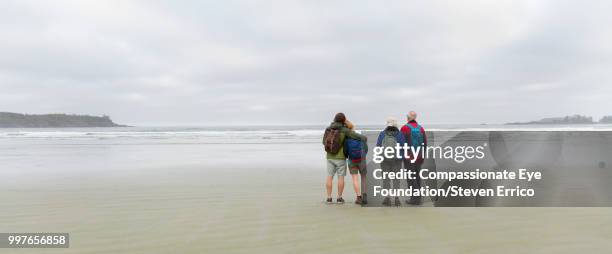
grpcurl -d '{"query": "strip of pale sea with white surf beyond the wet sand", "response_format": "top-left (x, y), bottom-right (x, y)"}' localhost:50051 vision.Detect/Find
top-left (0, 124), bottom-right (612, 143)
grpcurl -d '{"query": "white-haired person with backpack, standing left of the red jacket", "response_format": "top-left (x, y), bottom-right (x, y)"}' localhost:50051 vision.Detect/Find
top-left (376, 118), bottom-right (406, 206)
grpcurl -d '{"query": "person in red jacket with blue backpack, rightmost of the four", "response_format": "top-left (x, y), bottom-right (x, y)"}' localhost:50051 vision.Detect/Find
top-left (400, 111), bottom-right (427, 205)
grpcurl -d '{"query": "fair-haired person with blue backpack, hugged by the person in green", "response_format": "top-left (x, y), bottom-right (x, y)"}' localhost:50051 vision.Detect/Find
top-left (344, 120), bottom-right (368, 205)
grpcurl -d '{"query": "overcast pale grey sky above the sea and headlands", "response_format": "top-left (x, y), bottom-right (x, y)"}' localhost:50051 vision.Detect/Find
top-left (0, 0), bottom-right (612, 125)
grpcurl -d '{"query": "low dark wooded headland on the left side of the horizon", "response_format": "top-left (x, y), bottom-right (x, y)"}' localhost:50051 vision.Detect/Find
top-left (0, 112), bottom-right (128, 128)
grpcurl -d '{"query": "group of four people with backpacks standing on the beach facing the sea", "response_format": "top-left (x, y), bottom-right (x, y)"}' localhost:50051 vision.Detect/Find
top-left (323, 111), bottom-right (427, 206)
